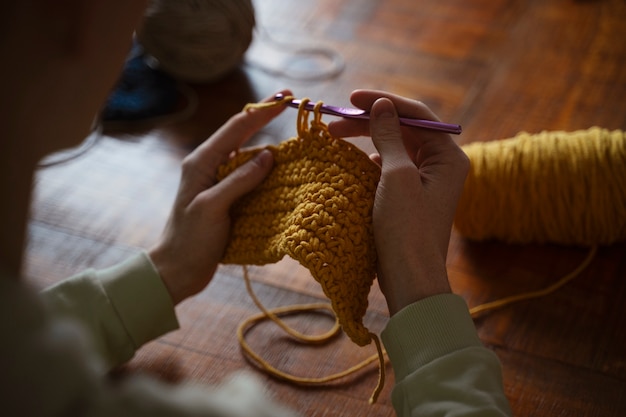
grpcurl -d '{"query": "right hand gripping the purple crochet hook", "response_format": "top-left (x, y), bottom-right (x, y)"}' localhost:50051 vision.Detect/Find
top-left (329, 90), bottom-right (469, 315)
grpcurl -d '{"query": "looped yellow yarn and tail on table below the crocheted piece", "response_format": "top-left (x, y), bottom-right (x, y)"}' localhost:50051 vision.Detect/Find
top-left (237, 265), bottom-right (385, 404)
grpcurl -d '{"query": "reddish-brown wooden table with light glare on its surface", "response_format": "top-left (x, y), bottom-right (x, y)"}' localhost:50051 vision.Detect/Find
top-left (26, 0), bottom-right (626, 417)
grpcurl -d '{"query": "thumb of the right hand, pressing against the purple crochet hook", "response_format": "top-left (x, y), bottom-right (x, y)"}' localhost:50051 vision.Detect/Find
top-left (370, 98), bottom-right (411, 168)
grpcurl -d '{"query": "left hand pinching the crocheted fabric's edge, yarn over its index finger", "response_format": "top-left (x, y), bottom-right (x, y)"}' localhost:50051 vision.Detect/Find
top-left (148, 91), bottom-right (291, 304)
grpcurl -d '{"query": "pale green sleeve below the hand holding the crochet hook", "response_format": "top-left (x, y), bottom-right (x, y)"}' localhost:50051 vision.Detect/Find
top-left (382, 294), bottom-right (511, 417)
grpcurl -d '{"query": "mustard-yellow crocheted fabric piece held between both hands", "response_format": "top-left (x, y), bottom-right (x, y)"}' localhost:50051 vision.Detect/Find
top-left (218, 100), bottom-right (380, 346)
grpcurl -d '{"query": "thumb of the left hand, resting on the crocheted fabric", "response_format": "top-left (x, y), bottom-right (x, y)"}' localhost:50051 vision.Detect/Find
top-left (207, 149), bottom-right (274, 212)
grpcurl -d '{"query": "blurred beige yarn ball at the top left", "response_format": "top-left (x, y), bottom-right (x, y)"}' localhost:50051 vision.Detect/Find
top-left (137, 0), bottom-right (255, 82)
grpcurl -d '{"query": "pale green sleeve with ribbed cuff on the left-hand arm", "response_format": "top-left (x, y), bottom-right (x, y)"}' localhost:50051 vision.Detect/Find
top-left (41, 252), bottom-right (178, 369)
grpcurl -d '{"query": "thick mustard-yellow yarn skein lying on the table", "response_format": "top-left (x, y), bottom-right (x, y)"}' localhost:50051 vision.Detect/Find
top-left (455, 127), bottom-right (626, 246)
